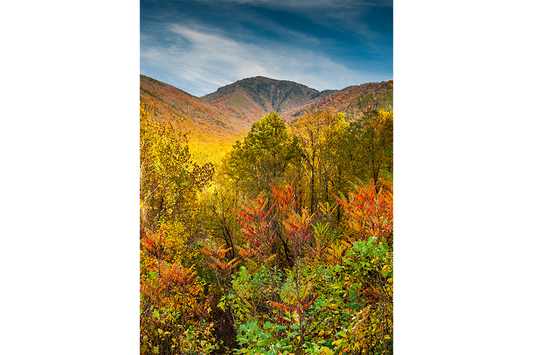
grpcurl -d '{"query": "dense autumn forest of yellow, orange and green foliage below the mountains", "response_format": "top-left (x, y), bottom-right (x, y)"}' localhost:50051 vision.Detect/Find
top-left (137, 81), bottom-right (396, 354)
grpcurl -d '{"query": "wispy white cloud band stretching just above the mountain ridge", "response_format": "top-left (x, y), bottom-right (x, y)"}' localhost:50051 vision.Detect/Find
top-left (137, 24), bottom-right (378, 96)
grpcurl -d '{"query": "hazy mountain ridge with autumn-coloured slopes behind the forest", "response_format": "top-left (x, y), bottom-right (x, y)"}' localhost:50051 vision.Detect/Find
top-left (137, 74), bottom-right (396, 144)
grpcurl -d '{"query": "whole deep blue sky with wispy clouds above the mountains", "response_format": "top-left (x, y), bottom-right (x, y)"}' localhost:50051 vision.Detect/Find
top-left (137, 0), bottom-right (396, 96)
